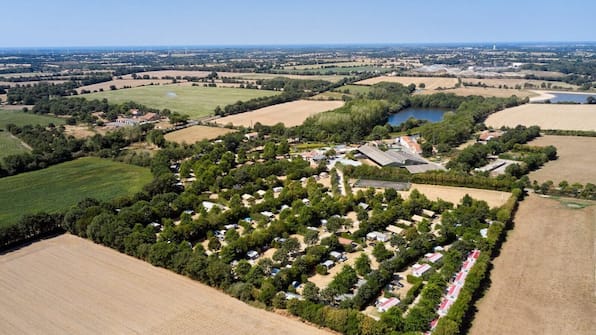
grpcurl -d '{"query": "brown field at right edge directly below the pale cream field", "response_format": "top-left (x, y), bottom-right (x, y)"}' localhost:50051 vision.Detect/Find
top-left (528, 136), bottom-right (596, 185)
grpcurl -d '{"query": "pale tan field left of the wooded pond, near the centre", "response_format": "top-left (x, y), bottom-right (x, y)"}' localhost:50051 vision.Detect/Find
top-left (214, 100), bottom-right (344, 127)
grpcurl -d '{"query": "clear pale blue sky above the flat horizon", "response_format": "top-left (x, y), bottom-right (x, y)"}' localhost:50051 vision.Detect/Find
top-left (0, 0), bottom-right (596, 48)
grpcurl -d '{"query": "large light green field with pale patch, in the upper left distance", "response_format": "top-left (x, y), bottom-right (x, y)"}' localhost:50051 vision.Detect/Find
top-left (79, 85), bottom-right (280, 118)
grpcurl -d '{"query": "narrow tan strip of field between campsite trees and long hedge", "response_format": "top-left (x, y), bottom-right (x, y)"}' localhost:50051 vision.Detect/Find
top-left (398, 184), bottom-right (510, 208)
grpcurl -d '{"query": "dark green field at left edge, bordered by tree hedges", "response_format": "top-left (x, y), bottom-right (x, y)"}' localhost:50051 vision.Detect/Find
top-left (0, 157), bottom-right (151, 224)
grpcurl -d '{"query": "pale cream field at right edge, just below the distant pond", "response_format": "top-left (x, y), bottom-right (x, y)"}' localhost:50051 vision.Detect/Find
top-left (484, 104), bottom-right (596, 130)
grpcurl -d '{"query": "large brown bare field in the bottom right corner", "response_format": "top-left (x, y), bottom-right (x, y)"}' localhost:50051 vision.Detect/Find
top-left (469, 194), bottom-right (596, 335)
